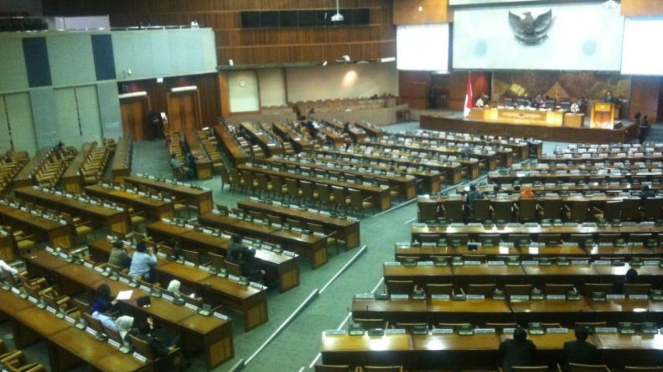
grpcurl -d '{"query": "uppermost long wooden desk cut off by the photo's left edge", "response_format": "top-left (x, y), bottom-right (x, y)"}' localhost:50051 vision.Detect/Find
top-left (0, 204), bottom-right (71, 248)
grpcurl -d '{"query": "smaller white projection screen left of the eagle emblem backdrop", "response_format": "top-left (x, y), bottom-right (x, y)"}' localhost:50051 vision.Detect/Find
top-left (396, 24), bottom-right (449, 72)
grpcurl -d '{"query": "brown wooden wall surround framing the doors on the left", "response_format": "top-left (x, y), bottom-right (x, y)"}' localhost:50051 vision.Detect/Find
top-left (118, 74), bottom-right (221, 126)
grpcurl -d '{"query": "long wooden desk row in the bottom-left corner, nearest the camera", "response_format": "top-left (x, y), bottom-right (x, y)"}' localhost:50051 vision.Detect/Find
top-left (0, 290), bottom-right (154, 372)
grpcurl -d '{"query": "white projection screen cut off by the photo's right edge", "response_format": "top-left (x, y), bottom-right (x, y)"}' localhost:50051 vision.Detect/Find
top-left (622, 17), bottom-right (663, 75)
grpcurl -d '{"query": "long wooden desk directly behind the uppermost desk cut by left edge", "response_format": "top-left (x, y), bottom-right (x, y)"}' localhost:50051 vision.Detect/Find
top-left (14, 187), bottom-right (131, 234)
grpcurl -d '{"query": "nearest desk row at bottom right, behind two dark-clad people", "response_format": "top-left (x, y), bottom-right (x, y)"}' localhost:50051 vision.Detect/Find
top-left (321, 331), bottom-right (663, 371)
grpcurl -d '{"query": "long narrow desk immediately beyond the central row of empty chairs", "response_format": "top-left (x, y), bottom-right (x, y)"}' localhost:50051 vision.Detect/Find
top-left (238, 164), bottom-right (391, 211)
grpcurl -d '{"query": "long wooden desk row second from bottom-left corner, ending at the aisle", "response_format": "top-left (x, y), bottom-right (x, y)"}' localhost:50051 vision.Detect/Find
top-left (24, 250), bottom-right (234, 370)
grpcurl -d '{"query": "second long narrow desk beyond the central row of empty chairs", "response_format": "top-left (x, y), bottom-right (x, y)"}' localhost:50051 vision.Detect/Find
top-left (265, 157), bottom-right (417, 200)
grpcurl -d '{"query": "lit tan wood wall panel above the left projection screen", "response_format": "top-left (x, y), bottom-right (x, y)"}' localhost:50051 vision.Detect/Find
top-left (393, 0), bottom-right (453, 25)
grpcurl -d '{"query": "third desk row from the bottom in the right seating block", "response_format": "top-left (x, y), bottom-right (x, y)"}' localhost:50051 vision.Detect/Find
top-left (383, 257), bottom-right (663, 291)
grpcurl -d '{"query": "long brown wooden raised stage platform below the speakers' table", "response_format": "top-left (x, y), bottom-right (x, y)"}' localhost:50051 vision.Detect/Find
top-left (420, 112), bottom-right (638, 143)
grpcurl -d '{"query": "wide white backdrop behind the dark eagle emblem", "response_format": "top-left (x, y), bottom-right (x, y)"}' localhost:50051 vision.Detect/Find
top-left (452, 3), bottom-right (624, 71)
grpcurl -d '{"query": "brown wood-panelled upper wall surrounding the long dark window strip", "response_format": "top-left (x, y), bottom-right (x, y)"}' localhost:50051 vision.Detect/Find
top-left (44, 0), bottom-right (396, 65)
